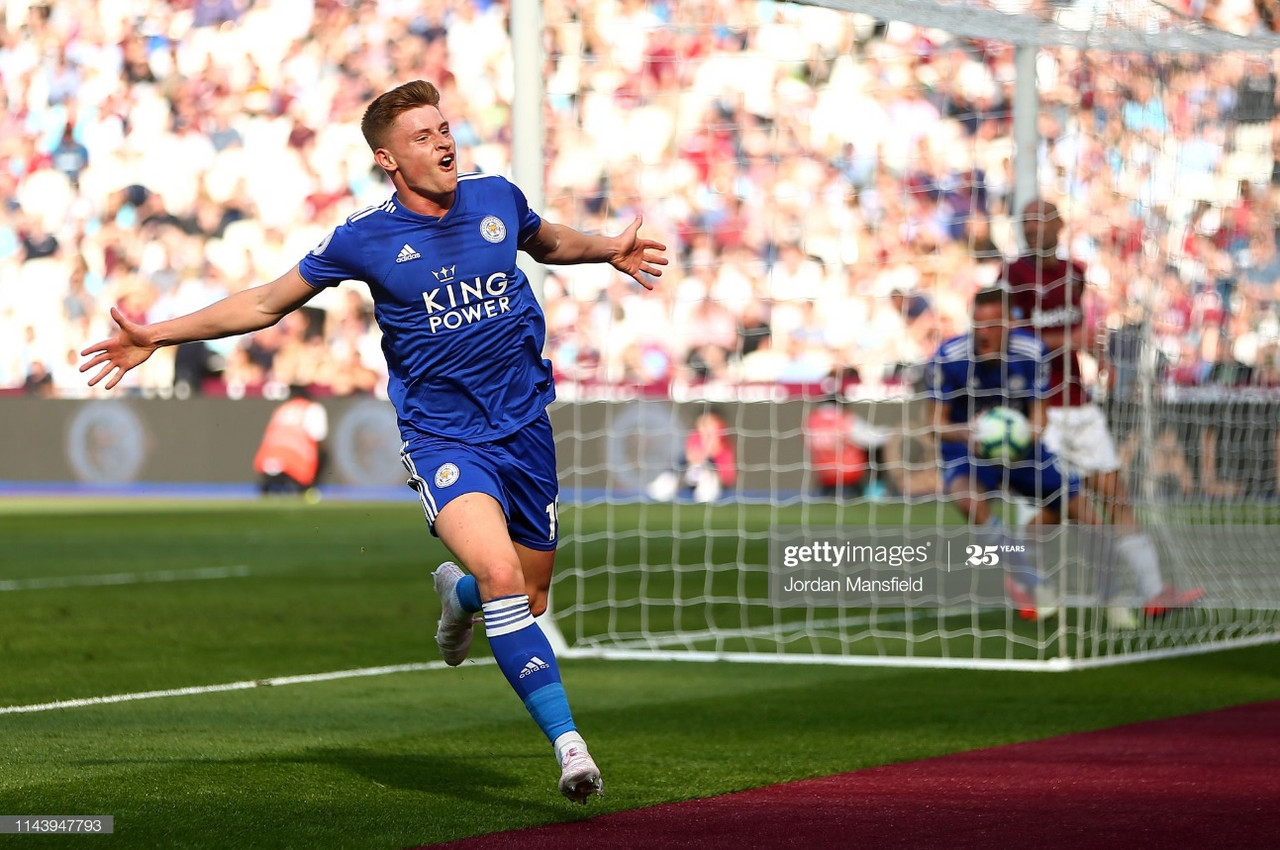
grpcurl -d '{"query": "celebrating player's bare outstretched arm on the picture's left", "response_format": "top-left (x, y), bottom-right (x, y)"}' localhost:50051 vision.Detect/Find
top-left (81, 266), bottom-right (319, 389)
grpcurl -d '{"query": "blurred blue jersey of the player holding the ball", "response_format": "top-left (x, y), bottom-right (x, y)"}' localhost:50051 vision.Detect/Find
top-left (924, 329), bottom-right (1048, 424)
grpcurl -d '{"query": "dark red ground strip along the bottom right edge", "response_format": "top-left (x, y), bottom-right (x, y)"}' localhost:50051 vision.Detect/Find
top-left (427, 702), bottom-right (1280, 850)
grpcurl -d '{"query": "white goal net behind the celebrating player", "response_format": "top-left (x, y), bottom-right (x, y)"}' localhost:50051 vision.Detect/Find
top-left (541, 0), bottom-right (1280, 668)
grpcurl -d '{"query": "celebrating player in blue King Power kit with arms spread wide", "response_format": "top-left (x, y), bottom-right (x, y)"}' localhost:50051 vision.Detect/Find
top-left (81, 81), bottom-right (667, 803)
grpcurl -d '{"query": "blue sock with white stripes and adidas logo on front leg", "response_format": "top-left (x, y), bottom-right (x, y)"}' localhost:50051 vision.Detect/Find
top-left (484, 594), bottom-right (575, 742)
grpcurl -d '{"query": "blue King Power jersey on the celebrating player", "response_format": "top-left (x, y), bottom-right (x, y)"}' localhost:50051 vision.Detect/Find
top-left (298, 174), bottom-right (556, 442)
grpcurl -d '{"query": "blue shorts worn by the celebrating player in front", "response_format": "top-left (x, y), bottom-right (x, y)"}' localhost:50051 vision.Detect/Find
top-left (401, 411), bottom-right (559, 552)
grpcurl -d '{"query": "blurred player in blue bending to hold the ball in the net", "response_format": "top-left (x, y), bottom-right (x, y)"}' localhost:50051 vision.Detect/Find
top-left (924, 288), bottom-right (1098, 620)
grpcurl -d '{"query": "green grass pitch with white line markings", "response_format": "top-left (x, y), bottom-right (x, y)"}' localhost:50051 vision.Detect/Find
top-left (0, 501), bottom-right (1280, 850)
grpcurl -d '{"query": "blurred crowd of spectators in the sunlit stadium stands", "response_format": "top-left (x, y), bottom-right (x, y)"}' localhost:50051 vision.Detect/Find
top-left (0, 0), bottom-right (1280, 396)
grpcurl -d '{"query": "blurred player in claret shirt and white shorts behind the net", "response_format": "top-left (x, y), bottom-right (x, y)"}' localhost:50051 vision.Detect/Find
top-left (1000, 198), bottom-right (1204, 627)
